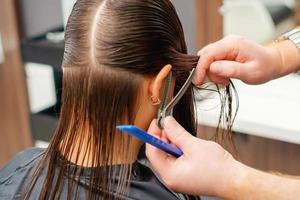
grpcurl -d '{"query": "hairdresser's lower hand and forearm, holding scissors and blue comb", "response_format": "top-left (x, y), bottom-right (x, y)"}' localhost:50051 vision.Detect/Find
top-left (146, 117), bottom-right (300, 200)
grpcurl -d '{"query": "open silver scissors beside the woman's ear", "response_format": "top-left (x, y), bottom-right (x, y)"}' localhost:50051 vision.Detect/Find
top-left (157, 68), bottom-right (195, 129)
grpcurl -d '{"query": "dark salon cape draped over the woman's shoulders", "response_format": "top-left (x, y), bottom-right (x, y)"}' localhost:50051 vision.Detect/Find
top-left (0, 148), bottom-right (200, 200)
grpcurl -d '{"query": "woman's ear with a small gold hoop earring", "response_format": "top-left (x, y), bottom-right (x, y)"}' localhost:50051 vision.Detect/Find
top-left (149, 65), bottom-right (172, 104)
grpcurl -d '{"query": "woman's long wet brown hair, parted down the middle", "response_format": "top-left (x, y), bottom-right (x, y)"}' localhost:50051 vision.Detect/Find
top-left (25, 0), bottom-right (237, 199)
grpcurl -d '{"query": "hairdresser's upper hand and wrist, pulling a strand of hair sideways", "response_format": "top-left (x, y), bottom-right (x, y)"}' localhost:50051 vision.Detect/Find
top-left (194, 36), bottom-right (300, 85)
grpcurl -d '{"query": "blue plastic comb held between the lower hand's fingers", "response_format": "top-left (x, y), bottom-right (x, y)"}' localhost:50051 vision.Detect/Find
top-left (117, 125), bottom-right (183, 158)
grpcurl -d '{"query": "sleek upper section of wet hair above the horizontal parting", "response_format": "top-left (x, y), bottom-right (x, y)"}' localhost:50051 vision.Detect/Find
top-left (64, 0), bottom-right (197, 72)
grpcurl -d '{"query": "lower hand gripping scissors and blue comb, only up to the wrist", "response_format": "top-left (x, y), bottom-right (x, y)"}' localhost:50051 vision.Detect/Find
top-left (146, 117), bottom-right (239, 196)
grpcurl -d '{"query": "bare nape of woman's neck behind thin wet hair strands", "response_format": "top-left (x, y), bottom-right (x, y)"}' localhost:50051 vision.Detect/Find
top-left (60, 132), bottom-right (142, 167)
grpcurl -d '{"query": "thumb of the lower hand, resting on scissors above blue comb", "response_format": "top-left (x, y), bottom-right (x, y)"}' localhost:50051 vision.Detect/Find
top-left (164, 116), bottom-right (193, 151)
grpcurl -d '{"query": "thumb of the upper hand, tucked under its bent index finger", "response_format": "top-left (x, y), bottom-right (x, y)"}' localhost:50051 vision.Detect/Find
top-left (209, 60), bottom-right (247, 79)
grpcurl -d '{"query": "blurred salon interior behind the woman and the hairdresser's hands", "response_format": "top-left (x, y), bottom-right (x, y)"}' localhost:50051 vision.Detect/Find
top-left (0, 0), bottom-right (300, 175)
